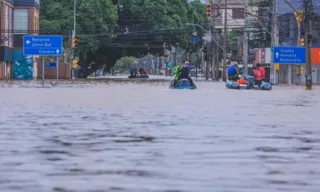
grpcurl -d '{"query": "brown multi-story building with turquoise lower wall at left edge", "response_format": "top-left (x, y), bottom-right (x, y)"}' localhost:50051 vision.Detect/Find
top-left (0, 0), bottom-right (40, 79)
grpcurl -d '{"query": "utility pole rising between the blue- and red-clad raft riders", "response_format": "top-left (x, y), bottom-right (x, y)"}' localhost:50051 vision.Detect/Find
top-left (242, 0), bottom-right (249, 75)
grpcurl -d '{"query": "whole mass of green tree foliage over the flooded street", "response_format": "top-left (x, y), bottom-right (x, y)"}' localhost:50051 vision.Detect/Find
top-left (40, 0), bottom-right (207, 77)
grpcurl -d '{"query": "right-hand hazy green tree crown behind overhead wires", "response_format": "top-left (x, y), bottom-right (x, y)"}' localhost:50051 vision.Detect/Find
top-left (114, 0), bottom-right (208, 59)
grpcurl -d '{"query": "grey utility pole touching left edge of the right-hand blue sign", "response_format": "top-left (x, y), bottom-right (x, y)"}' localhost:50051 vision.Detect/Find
top-left (270, 0), bottom-right (279, 84)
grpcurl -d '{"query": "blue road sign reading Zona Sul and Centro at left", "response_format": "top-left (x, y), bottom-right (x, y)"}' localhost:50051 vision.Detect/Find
top-left (23, 35), bottom-right (62, 56)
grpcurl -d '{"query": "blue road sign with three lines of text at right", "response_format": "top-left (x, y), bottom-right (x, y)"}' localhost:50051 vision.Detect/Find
top-left (273, 47), bottom-right (306, 65)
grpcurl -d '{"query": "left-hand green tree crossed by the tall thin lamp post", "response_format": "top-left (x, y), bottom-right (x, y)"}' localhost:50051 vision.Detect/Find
top-left (40, 0), bottom-right (117, 77)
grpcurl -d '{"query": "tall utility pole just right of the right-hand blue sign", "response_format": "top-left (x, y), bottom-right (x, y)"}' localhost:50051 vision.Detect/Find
top-left (304, 0), bottom-right (312, 90)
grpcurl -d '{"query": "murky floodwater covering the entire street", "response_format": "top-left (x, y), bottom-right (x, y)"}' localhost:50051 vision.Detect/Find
top-left (0, 82), bottom-right (320, 192)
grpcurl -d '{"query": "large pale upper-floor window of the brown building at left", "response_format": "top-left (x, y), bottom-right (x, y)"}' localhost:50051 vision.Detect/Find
top-left (13, 9), bottom-right (29, 34)
